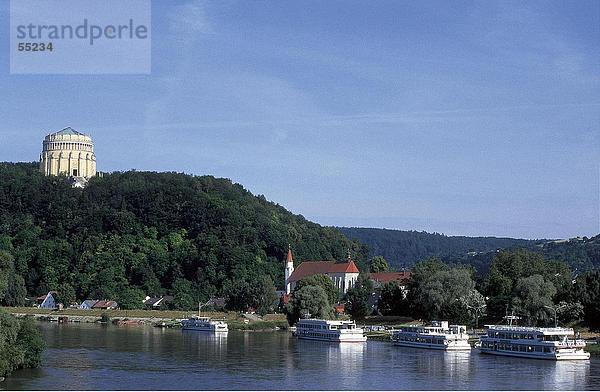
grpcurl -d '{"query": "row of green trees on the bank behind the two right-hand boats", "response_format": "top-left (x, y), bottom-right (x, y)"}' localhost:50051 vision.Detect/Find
top-left (379, 250), bottom-right (600, 329)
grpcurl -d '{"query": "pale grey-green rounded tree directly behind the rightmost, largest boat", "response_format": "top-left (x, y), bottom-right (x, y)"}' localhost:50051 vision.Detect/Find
top-left (513, 274), bottom-right (556, 325)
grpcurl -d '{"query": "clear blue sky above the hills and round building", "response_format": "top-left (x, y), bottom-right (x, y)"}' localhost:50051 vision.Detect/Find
top-left (0, 0), bottom-right (600, 238)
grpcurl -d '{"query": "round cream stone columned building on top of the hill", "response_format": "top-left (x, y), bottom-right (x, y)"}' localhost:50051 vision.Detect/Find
top-left (40, 127), bottom-right (96, 179)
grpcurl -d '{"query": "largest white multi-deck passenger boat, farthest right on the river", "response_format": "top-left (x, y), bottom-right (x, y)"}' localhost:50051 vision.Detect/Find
top-left (479, 316), bottom-right (590, 361)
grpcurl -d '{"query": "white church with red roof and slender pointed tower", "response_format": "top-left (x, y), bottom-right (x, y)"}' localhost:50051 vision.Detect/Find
top-left (285, 248), bottom-right (359, 294)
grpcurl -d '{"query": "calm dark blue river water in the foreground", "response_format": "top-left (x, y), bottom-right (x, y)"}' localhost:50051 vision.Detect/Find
top-left (0, 324), bottom-right (600, 390)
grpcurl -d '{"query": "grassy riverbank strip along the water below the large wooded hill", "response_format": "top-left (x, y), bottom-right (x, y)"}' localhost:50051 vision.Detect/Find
top-left (0, 307), bottom-right (288, 331)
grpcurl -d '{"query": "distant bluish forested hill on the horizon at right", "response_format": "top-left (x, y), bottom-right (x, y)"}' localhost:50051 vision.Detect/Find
top-left (338, 227), bottom-right (600, 274)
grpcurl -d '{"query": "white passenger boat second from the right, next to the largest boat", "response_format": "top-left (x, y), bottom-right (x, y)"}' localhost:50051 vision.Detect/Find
top-left (392, 321), bottom-right (471, 351)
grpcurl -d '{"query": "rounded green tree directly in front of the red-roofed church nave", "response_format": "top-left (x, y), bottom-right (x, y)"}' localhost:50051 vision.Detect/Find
top-left (286, 286), bottom-right (333, 325)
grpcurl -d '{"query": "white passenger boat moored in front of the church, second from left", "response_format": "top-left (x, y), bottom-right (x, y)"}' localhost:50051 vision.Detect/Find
top-left (294, 319), bottom-right (367, 342)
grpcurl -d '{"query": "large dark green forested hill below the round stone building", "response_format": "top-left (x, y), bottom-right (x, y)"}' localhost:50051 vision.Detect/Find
top-left (0, 163), bottom-right (367, 307)
